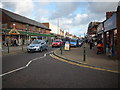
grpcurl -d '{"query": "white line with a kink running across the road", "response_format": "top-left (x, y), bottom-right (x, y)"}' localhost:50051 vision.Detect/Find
top-left (0, 51), bottom-right (53, 77)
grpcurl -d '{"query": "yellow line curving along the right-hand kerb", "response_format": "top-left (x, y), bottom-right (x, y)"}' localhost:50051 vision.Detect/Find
top-left (50, 54), bottom-right (120, 73)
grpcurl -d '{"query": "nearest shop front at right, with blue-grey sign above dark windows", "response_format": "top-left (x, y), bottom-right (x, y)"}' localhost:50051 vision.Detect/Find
top-left (104, 13), bottom-right (117, 56)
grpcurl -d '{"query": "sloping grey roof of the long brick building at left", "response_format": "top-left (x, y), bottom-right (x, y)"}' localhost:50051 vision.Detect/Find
top-left (0, 8), bottom-right (51, 30)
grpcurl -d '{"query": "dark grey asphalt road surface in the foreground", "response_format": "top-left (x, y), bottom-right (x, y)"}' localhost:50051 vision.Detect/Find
top-left (2, 47), bottom-right (119, 88)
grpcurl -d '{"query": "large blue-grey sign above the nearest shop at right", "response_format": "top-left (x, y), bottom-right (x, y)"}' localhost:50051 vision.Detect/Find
top-left (104, 13), bottom-right (116, 32)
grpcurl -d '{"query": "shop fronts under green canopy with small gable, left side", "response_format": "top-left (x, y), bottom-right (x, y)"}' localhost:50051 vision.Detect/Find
top-left (2, 29), bottom-right (53, 46)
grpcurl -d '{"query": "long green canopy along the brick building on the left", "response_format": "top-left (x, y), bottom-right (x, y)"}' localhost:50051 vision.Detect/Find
top-left (2, 29), bottom-right (54, 37)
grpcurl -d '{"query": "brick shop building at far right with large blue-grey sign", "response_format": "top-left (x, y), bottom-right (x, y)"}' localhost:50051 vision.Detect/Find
top-left (97, 11), bottom-right (120, 60)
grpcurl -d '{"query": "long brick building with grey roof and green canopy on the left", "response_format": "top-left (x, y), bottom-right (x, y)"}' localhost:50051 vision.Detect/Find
top-left (0, 9), bottom-right (51, 45)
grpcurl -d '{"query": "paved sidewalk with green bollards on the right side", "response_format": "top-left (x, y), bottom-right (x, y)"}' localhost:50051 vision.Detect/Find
top-left (54, 45), bottom-right (120, 71)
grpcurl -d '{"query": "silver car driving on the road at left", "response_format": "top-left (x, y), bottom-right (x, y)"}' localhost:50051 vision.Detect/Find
top-left (27, 40), bottom-right (48, 53)
